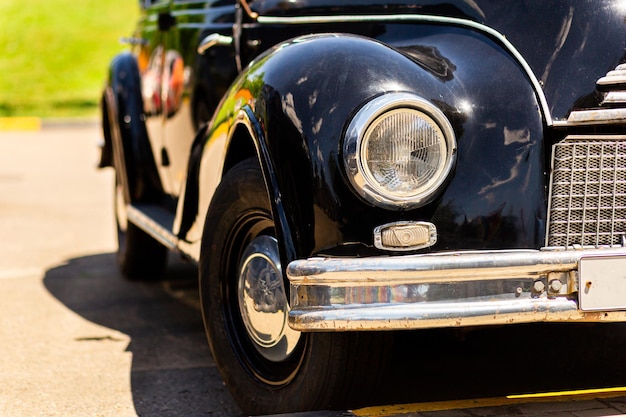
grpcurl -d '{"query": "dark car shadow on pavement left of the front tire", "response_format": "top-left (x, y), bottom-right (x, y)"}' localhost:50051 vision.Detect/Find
top-left (44, 254), bottom-right (241, 417)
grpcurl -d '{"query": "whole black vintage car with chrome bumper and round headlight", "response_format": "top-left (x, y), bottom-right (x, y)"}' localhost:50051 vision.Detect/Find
top-left (101, 0), bottom-right (626, 414)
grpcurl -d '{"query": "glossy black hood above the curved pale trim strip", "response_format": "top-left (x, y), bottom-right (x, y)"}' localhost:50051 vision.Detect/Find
top-left (244, 0), bottom-right (626, 119)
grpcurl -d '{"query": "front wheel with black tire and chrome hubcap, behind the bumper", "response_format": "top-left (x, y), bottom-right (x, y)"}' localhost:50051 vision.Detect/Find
top-left (199, 159), bottom-right (390, 415)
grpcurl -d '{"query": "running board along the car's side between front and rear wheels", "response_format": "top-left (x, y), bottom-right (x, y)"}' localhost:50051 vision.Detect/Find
top-left (126, 204), bottom-right (180, 251)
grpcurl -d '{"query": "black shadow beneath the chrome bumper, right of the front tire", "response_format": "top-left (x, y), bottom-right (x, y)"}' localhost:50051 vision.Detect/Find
top-left (378, 316), bottom-right (626, 403)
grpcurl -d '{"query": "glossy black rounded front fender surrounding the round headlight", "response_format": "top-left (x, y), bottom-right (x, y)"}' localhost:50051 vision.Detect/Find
top-left (189, 24), bottom-right (545, 261)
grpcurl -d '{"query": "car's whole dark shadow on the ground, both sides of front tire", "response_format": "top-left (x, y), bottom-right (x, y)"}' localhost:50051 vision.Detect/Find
top-left (45, 254), bottom-right (626, 416)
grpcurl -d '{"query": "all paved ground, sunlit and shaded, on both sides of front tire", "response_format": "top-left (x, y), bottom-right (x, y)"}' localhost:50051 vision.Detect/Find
top-left (0, 125), bottom-right (626, 417)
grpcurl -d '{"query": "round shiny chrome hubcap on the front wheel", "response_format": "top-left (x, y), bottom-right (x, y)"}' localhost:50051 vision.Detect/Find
top-left (238, 235), bottom-right (300, 362)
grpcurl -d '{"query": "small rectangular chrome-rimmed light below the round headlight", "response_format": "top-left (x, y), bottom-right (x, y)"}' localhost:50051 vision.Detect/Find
top-left (374, 222), bottom-right (437, 251)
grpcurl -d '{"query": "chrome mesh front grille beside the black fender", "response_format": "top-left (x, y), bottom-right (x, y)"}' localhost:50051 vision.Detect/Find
top-left (546, 136), bottom-right (626, 247)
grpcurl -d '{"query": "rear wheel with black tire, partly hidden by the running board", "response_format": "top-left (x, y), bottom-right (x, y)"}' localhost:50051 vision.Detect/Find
top-left (114, 170), bottom-right (168, 281)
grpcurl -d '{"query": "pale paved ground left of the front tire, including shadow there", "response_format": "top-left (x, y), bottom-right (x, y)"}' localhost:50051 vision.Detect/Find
top-left (0, 126), bottom-right (238, 417)
